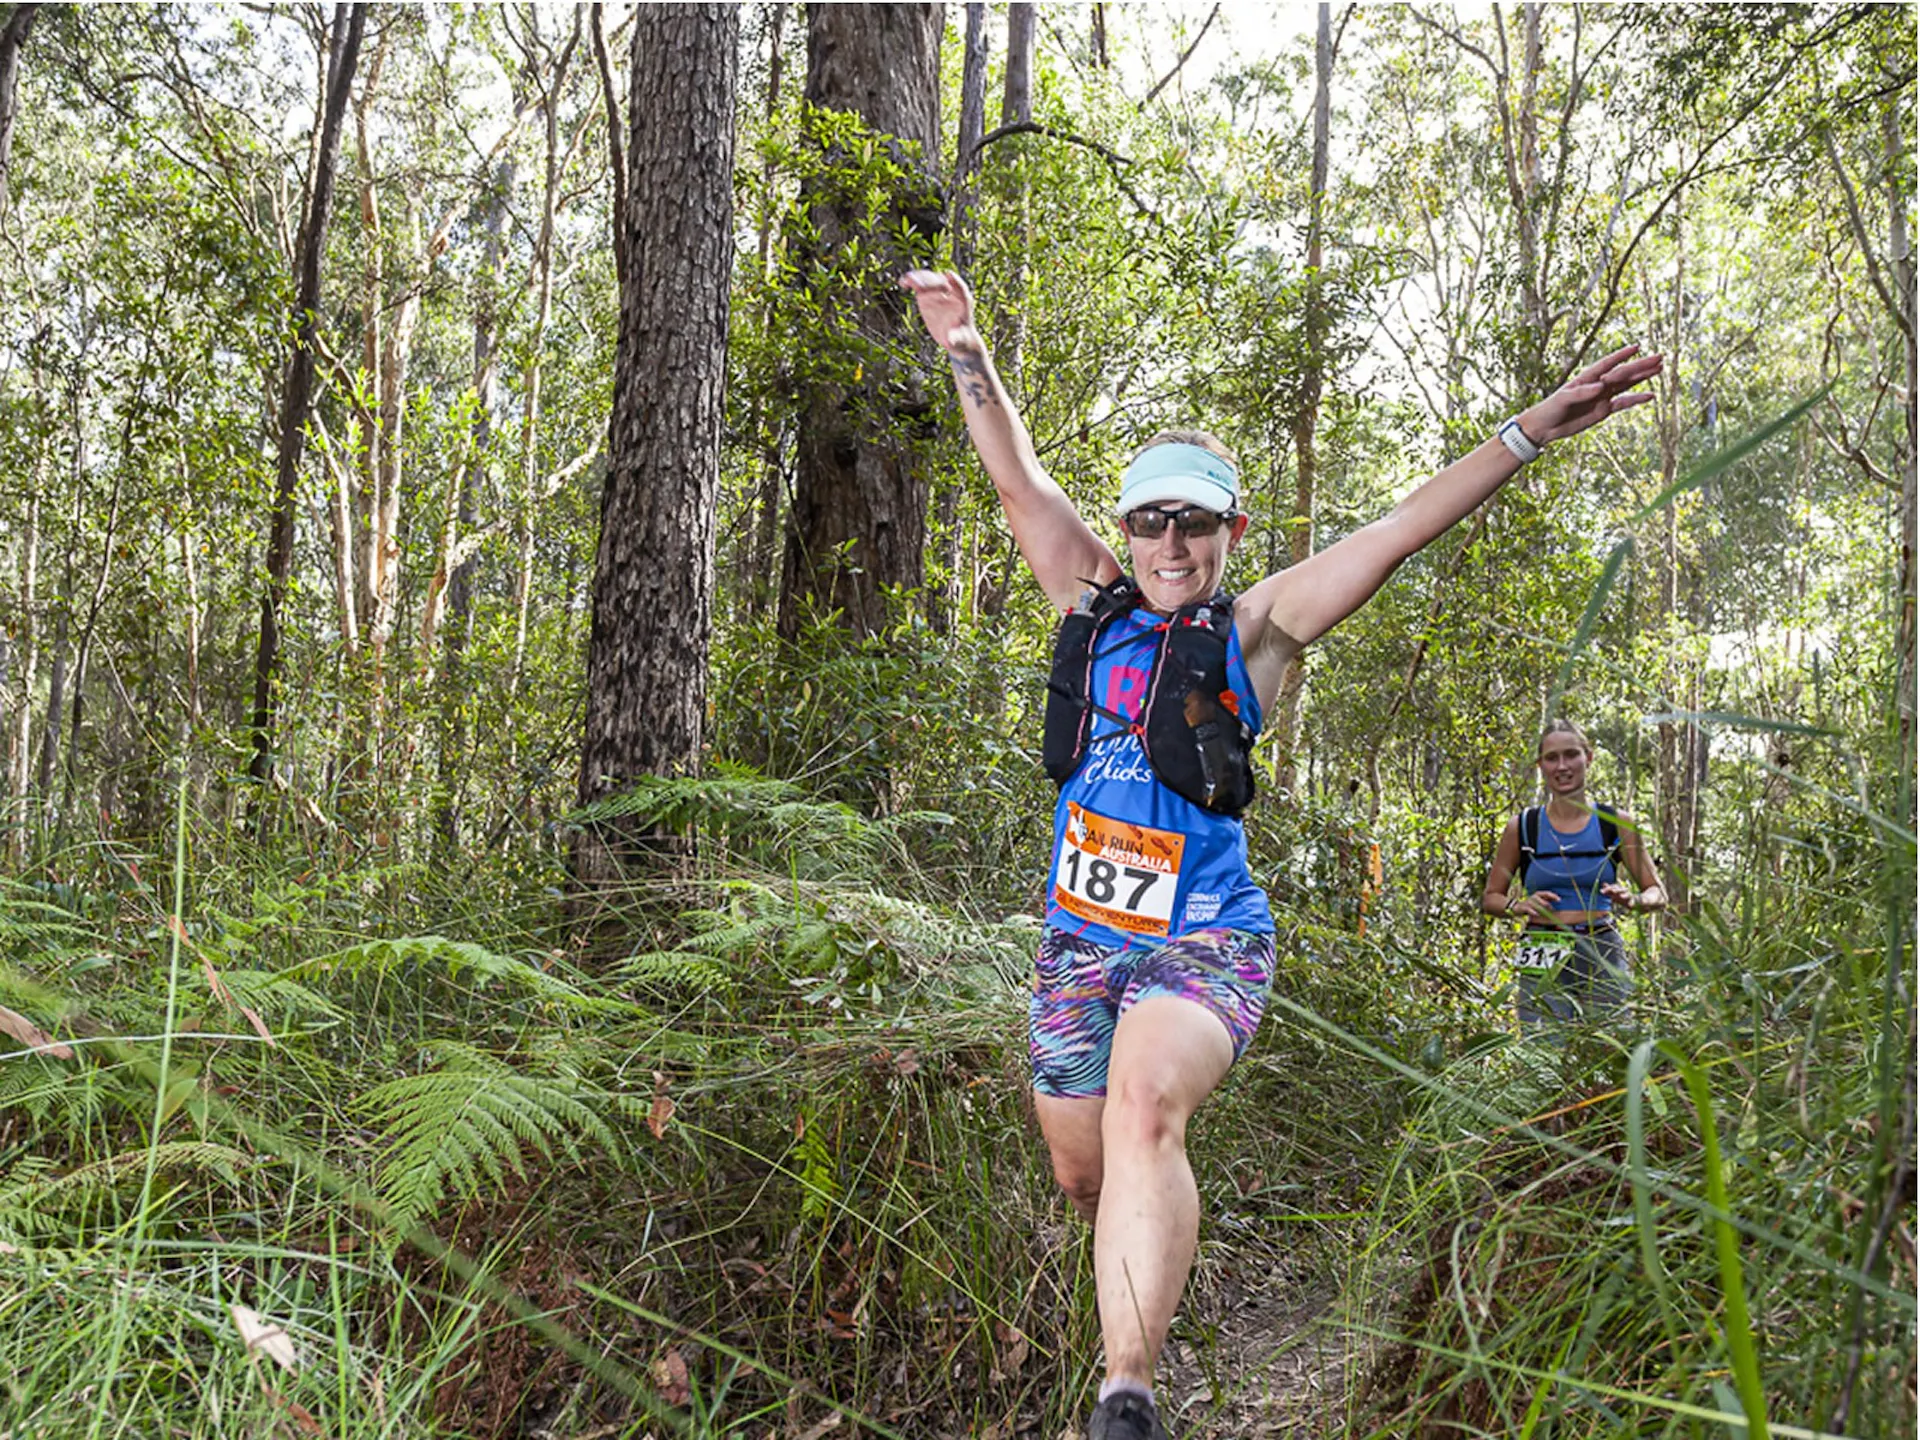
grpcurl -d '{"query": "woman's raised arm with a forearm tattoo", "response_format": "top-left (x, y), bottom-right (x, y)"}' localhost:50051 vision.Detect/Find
top-left (900, 271), bottom-right (1121, 611)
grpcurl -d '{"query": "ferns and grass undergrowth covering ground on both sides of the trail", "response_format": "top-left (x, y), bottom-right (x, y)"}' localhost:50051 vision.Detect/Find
top-left (0, 772), bottom-right (1914, 1440)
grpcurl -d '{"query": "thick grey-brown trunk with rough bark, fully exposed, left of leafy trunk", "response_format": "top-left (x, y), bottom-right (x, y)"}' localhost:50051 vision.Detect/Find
top-left (574, 4), bottom-right (739, 883)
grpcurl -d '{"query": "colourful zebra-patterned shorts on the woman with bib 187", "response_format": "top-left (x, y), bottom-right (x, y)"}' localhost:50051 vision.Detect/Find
top-left (1027, 929), bottom-right (1273, 1100)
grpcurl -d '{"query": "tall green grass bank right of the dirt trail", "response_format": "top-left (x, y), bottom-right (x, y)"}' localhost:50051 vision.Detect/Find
top-left (1344, 716), bottom-right (1916, 1440)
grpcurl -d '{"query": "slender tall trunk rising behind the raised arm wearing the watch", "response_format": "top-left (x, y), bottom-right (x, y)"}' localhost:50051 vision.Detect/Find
top-left (1275, 0), bottom-right (1332, 793)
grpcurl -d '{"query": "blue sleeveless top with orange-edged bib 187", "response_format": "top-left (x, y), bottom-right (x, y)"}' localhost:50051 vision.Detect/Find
top-left (1046, 609), bottom-right (1273, 950)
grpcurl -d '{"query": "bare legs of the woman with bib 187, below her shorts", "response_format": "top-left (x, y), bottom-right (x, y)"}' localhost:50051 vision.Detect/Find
top-left (1035, 995), bottom-right (1233, 1388)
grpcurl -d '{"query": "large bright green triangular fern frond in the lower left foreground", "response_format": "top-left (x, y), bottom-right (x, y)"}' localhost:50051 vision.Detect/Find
top-left (357, 1044), bottom-right (618, 1233)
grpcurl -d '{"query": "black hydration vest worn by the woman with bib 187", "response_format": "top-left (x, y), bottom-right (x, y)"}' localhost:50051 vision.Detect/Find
top-left (1041, 576), bottom-right (1254, 818)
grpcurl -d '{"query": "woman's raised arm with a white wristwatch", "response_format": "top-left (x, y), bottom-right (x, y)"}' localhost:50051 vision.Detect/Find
top-left (1235, 346), bottom-right (1661, 705)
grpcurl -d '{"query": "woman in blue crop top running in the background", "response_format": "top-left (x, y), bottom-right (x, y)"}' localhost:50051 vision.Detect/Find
top-left (1480, 720), bottom-right (1667, 1027)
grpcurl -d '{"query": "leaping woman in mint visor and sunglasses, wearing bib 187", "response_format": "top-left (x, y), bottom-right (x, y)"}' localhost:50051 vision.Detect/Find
top-left (900, 271), bottom-right (1661, 1440)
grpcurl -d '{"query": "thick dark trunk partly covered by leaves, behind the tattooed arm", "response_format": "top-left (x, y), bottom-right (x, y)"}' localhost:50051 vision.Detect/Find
top-left (780, 4), bottom-right (945, 636)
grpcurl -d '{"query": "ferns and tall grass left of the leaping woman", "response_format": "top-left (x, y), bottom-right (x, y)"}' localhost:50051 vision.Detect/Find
top-left (0, 783), bottom-right (1092, 1436)
